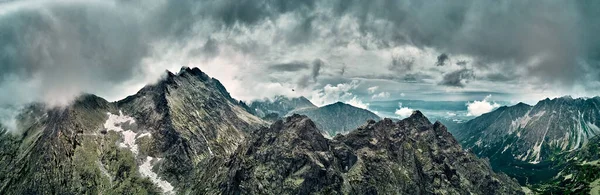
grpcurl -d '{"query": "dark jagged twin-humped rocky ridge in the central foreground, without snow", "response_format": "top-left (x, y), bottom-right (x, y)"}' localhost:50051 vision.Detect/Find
top-left (204, 111), bottom-right (522, 194)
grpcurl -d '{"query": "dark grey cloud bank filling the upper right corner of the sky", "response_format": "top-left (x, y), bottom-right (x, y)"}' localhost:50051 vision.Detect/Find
top-left (333, 0), bottom-right (600, 87)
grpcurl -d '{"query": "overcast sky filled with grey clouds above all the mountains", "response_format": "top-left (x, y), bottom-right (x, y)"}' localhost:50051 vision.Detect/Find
top-left (0, 0), bottom-right (600, 109)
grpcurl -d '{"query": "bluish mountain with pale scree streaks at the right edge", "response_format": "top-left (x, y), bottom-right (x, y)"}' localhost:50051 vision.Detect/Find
top-left (453, 97), bottom-right (600, 188)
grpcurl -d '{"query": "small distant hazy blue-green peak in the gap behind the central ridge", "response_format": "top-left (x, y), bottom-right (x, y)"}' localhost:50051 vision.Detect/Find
top-left (294, 102), bottom-right (381, 137)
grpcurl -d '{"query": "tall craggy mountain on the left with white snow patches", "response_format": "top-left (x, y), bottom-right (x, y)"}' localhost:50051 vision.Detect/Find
top-left (0, 68), bottom-right (265, 194)
